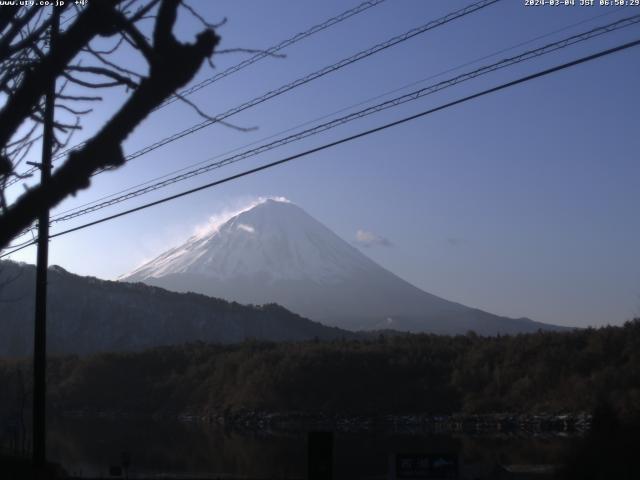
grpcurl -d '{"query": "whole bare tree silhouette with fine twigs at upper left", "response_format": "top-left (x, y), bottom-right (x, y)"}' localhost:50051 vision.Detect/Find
top-left (0, 0), bottom-right (219, 249)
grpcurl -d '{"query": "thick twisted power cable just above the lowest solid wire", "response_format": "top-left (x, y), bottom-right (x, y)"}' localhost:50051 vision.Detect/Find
top-left (33, 14), bottom-right (640, 224)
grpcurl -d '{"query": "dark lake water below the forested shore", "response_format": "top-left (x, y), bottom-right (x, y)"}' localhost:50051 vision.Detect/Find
top-left (48, 418), bottom-right (575, 479)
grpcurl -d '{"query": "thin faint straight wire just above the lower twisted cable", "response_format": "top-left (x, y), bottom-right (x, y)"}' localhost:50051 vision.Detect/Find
top-left (43, 7), bottom-right (624, 225)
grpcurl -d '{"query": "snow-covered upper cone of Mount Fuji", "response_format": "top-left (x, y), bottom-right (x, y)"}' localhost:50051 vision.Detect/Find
top-left (121, 199), bottom-right (376, 283)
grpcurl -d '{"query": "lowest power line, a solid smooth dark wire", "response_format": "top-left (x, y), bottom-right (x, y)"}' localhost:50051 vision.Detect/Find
top-left (0, 39), bottom-right (640, 258)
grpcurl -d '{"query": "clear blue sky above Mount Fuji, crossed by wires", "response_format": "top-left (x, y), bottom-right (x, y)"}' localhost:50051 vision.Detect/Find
top-left (5, 0), bottom-right (640, 326)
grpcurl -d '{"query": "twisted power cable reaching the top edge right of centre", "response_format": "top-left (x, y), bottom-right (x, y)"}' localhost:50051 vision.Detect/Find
top-left (7, 0), bottom-right (500, 186)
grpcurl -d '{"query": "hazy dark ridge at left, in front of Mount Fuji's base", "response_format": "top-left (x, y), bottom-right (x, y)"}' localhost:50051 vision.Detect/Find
top-left (0, 261), bottom-right (356, 356)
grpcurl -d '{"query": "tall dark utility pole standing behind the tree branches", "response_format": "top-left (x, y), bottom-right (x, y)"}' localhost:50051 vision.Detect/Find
top-left (33, 6), bottom-right (60, 476)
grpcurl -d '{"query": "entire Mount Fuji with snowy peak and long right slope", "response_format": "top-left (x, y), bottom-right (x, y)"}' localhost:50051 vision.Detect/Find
top-left (119, 199), bottom-right (562, 335)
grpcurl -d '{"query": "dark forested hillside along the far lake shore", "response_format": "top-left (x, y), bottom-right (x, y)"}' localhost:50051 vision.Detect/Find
top-left (0, 320), bottom-right (640, 418)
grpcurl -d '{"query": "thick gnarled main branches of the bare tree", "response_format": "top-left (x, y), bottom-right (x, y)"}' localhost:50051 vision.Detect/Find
top-left (0, 0), bottom-right (219, 248)
